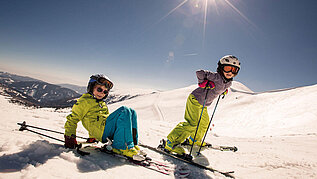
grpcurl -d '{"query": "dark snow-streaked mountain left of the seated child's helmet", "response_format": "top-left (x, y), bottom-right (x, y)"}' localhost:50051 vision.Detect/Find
top-left (0, 72), bottom-right (80, 108)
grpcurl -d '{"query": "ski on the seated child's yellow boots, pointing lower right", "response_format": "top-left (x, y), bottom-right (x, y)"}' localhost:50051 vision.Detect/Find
top-left (81, 145), bottom-right (174, 175)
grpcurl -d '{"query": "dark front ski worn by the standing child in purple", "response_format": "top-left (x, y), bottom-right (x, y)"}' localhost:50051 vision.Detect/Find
top-left (139, 143), bottom-right (235, 178)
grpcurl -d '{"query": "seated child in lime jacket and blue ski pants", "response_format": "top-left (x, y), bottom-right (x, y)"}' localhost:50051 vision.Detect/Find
top-left (65, 74), bottom-right (140, 157)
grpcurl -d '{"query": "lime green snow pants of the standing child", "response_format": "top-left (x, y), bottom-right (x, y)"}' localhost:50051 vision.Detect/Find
top-left (167, 94), bottom-right (209, 144)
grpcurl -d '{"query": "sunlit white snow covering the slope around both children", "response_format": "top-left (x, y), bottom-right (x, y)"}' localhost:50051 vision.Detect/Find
top-left (0, 82), bottom-right (317, 179)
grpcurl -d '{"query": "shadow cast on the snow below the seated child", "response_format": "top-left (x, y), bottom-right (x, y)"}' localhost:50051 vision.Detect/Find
top-left (0, 140), bottom-right (126, 173)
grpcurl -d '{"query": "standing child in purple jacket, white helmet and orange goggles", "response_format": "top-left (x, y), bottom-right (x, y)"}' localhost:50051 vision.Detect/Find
top-left (165, 55), bottom-right (240, 155)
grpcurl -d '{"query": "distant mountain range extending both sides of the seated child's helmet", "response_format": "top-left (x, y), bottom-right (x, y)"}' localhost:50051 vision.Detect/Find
top-left (0, 72), bottom-right (155, 108)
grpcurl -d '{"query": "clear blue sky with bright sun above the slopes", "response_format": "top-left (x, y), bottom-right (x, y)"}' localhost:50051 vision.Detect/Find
top-left (0, 0), bottom-right (317, 91)
